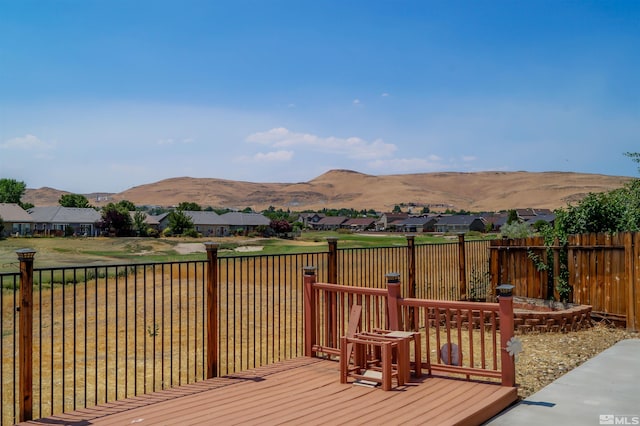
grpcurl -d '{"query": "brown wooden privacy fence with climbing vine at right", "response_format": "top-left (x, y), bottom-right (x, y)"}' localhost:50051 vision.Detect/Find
top-left (490, 232), bottom-right (640, 330)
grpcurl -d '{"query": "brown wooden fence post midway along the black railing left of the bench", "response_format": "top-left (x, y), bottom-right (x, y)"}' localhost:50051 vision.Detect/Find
top-left (204, 242), bottom-right (219, 379)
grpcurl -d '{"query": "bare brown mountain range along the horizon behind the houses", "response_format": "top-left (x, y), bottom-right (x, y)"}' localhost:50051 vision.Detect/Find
top-left (23, 170), bottom-right (631, 211)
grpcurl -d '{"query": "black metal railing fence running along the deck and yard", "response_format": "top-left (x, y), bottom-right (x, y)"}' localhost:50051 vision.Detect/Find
top-left (0, 238), bottom-right (488, 424)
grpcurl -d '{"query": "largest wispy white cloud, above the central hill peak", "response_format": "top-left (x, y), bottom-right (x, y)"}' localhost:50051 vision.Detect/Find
top-left (246, 127), bottom-right (397, 160)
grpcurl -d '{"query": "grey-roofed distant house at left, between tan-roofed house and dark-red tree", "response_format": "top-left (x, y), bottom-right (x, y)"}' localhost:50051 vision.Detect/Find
top-left (29, 206), bottom-right (102, 237)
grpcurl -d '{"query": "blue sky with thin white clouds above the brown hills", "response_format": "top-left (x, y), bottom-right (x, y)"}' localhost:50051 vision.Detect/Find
top-left (0, 0), bottom-right (640, 193)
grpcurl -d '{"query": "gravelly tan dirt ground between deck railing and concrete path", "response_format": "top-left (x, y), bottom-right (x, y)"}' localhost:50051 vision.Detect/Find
top-left (516, 323), bottom-right (640, 398)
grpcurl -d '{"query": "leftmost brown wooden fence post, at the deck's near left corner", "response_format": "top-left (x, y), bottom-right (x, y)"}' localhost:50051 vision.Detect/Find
top-left (16, 249), bottom-right (36, 422)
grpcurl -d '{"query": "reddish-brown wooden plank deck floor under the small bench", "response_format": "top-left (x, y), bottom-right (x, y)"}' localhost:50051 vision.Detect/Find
top-left (27, 358), bottom-right (517, 425)
